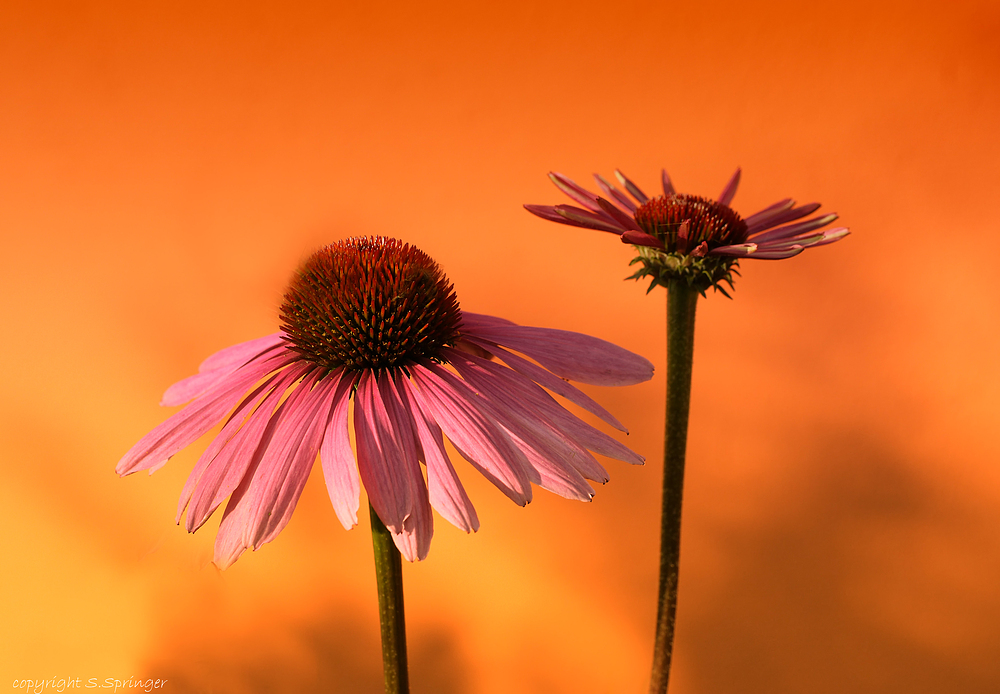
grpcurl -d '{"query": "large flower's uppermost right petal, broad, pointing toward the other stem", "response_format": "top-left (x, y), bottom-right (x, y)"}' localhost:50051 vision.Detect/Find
top-left (467, 325), bottom-right (653, 386)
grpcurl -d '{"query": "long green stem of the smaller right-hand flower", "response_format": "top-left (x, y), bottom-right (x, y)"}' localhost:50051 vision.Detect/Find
top-left (649, 281), bottom-right (698, 694)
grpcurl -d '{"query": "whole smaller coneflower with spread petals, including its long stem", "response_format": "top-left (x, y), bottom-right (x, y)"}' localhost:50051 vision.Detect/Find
top-left (524, 169), bottom-right (850, 694)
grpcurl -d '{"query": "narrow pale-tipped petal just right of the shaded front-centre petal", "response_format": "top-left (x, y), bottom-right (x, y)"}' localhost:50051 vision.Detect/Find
top-left (400, 378), bottom-right (479, 532)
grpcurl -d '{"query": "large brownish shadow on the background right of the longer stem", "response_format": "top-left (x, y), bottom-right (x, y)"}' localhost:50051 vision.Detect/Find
top-left (678, 432), bottom-right (1000, 694)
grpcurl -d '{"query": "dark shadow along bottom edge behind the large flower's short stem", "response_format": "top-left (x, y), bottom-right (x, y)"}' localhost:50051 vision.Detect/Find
top-left (146, 610), bottom-right (469, 694)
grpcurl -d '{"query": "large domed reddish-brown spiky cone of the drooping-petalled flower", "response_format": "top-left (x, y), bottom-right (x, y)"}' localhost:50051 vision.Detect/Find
top-left (281, 237), bottom-right (461, 371)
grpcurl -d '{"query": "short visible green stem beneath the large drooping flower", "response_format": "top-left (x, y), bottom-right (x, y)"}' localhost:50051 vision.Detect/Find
top-left (368, 504), bottom-right (410, 694)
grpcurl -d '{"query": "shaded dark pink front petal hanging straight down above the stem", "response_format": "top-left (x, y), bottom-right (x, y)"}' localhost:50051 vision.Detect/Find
top-left (354, 371), bottom-right (415, 533)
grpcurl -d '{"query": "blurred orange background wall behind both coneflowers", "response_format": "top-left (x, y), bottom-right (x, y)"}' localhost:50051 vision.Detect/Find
top-left (0, 0), bottom-right (1000, 694)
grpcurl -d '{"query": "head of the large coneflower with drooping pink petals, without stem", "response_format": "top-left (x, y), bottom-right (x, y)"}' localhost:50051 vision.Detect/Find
top-left (116, 238), bottom-right (653, 568)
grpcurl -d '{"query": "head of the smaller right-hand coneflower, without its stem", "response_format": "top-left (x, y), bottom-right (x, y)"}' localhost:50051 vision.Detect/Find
top-left (524, 169), bottom-right (849, 293)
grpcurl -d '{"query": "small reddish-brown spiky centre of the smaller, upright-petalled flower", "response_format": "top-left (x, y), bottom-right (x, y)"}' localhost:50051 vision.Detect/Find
top-left (635, 194), bottom-right (747, 253)
